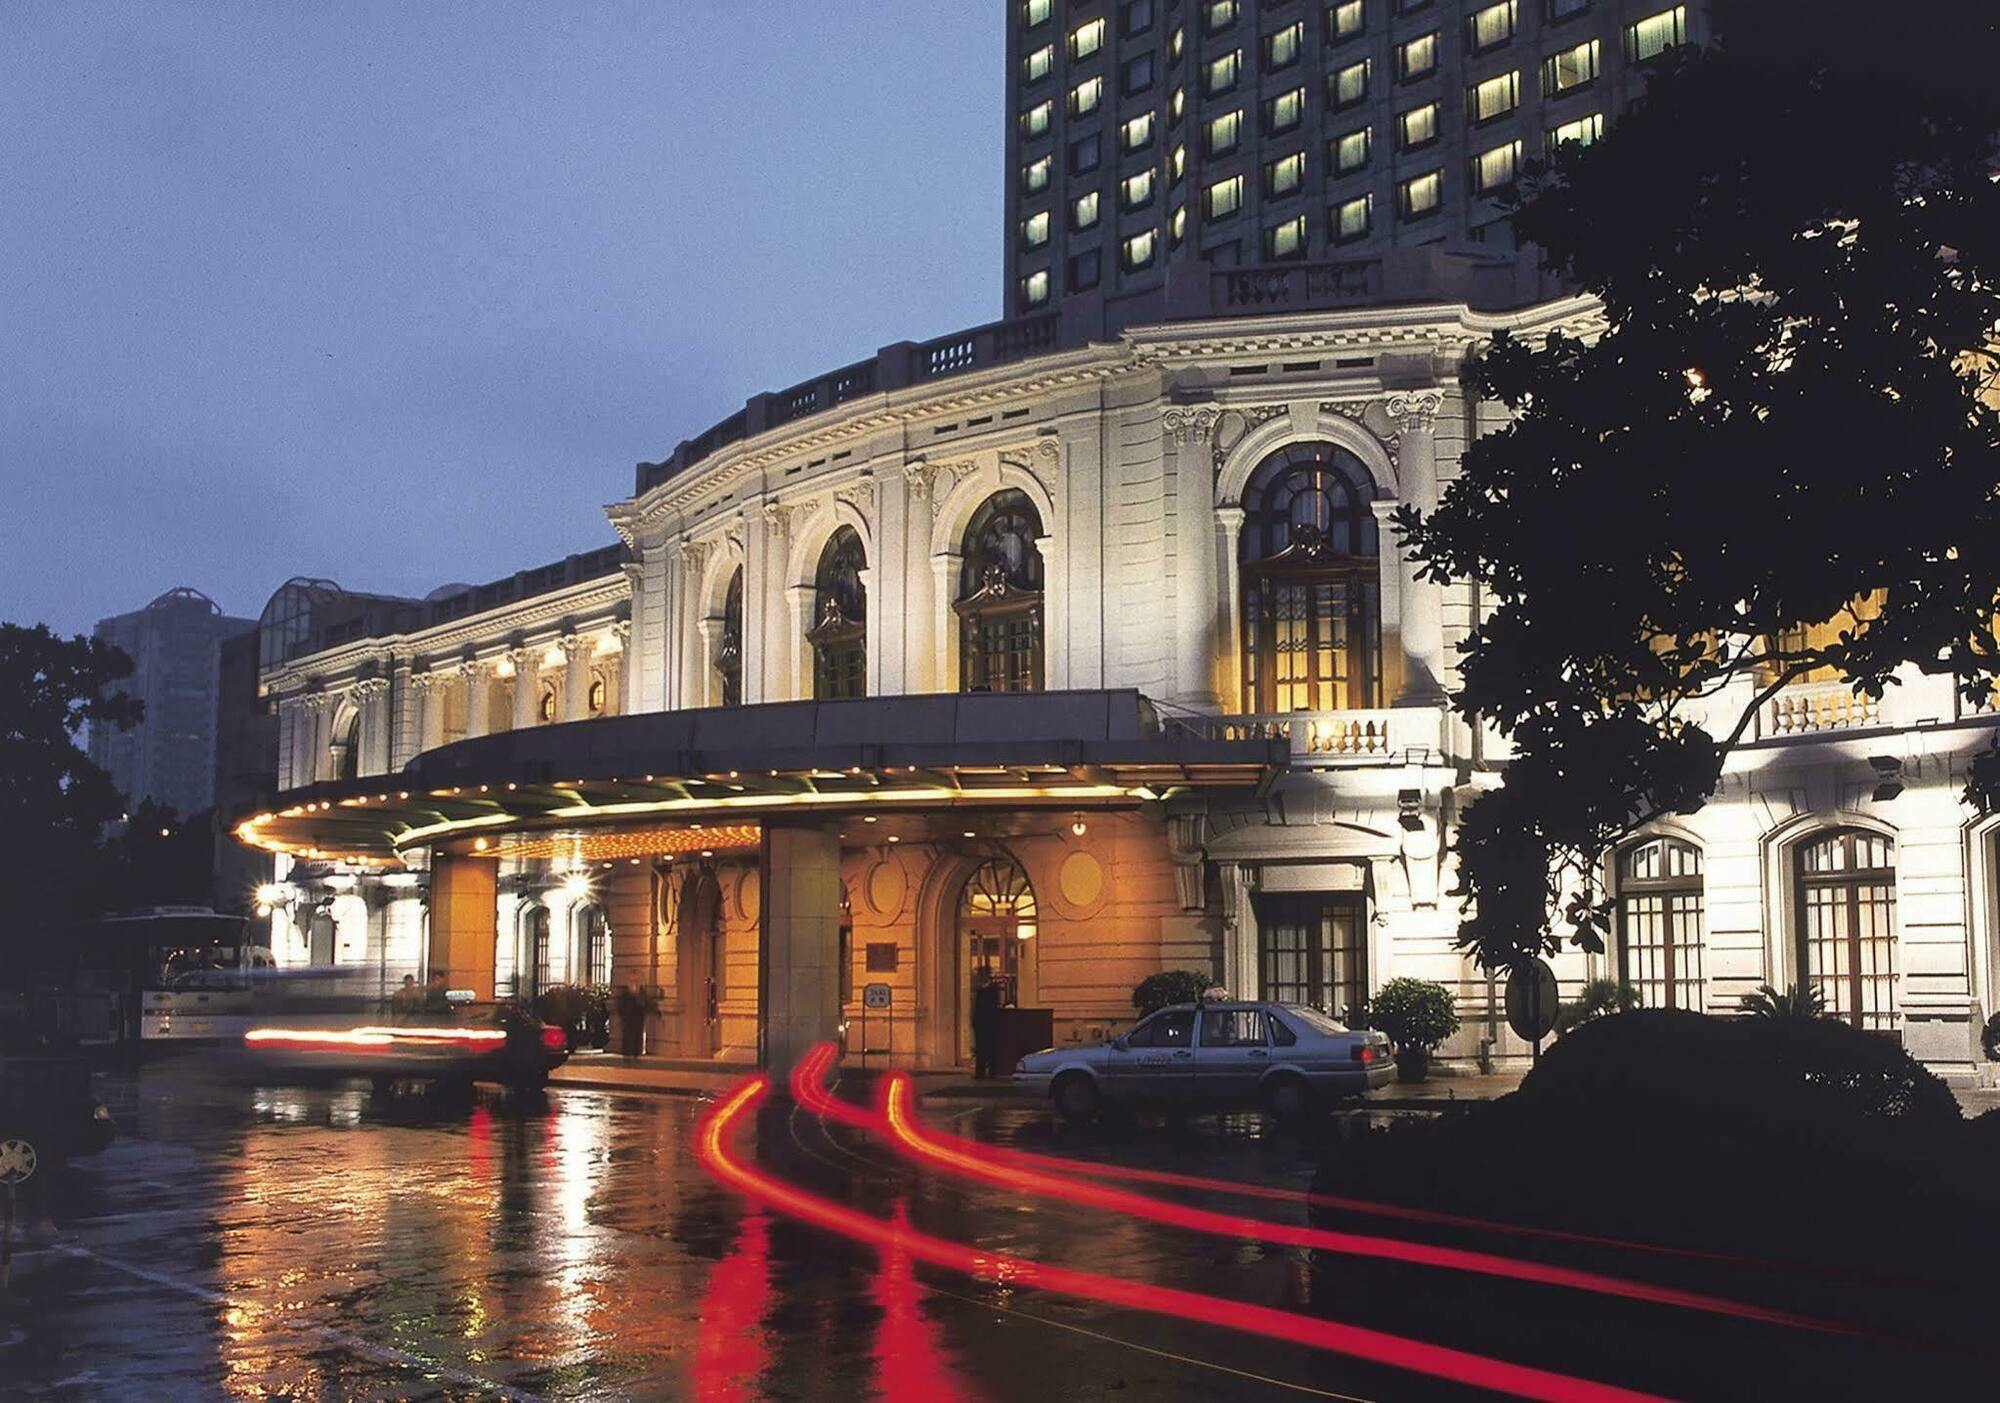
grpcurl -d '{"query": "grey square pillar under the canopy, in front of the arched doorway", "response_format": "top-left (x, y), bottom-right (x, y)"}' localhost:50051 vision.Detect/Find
top-left (758, 821), bottom-right (840, 1077)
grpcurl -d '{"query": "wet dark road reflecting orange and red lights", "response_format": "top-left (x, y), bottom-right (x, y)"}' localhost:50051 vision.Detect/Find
top-left (0, 1065), bottom-right (1976, 1403)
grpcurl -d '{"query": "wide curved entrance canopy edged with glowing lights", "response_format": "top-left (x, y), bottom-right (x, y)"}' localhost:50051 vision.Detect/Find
top-left (236, 692), bottom-right (1288, 865)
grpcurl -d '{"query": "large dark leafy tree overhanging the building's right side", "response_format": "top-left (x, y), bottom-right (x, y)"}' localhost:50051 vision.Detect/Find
top-left (1398, 0), bottom-right (2000, 967)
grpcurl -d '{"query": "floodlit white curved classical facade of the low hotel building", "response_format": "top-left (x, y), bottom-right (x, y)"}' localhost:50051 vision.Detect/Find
top-left (242, 294), bottom-right (1996, 1073)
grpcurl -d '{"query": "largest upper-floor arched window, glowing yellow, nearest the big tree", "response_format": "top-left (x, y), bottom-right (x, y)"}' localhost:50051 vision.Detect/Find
top-left (1238, 444), bottom-right (1382, 711)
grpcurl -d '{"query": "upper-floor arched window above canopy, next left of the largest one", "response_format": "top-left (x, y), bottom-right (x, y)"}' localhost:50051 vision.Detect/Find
top-left (952, 488), bottom-right (1042, 692)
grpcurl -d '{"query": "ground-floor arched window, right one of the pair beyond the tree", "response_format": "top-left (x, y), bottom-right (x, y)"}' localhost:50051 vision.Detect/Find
top-left (1798, 827), bottom-right (1896, 1033)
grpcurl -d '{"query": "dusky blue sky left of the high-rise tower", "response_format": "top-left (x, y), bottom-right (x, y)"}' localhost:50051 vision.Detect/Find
top-left (0, 0), bottom-right (1004, 632)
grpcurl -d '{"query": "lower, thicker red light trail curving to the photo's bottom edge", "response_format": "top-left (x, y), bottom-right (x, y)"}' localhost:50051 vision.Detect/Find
top-left (694, 1077), bottom-right (1652, 1401)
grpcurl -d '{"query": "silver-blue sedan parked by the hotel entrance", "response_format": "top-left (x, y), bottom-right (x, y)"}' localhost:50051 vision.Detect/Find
top-left (1014, 1003), bottom-right (1396, 1119)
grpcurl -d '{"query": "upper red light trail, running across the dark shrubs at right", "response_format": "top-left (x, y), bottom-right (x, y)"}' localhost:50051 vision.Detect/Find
top-left (882, 1071), bottom-right (1864, 1335)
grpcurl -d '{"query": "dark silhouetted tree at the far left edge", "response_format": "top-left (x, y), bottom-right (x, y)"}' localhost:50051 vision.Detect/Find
top-left (0, 624), bottom-right (140, 939)
